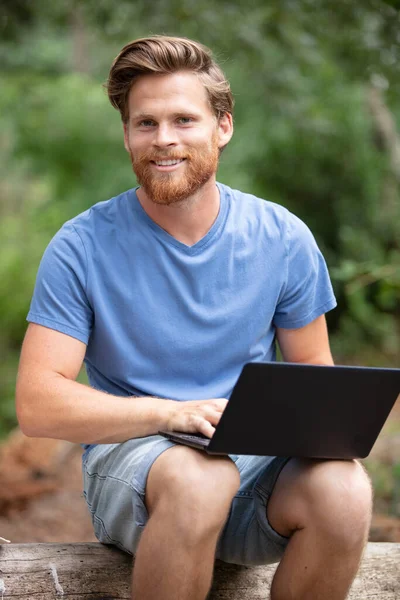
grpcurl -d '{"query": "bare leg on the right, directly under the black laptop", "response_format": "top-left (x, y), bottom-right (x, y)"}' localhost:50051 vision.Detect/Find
top-left (268, 460), bottom-right (372, 600)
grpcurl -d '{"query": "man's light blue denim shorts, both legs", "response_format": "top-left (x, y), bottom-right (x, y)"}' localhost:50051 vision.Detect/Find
top-left (82, 435), bottom-right (289, 565)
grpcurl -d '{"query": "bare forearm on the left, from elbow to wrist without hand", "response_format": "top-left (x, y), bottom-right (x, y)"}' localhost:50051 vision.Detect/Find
top-left (16, 373), bottom-right (176, 444)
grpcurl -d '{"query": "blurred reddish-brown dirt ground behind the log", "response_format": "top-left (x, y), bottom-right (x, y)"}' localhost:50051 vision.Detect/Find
top-left (0, 400), bottom-right (400, 543)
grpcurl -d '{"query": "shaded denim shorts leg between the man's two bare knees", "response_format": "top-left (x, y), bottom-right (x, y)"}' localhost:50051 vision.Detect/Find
top-left (216, 456), bottom-right (289, 565)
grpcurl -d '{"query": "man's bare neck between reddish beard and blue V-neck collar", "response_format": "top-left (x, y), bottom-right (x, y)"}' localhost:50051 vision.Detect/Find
top-left (137, 177), bottom-right (220, 246)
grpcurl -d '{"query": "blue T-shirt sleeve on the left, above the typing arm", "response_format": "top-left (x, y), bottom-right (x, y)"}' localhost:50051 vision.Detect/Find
top-left (27, 223), bottom-right (93, 344)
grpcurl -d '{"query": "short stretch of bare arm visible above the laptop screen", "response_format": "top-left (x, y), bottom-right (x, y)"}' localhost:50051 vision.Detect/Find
top-left (276, 315), bottom-right (333, 365)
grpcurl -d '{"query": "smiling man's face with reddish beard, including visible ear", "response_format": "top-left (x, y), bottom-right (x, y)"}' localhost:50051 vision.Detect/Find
top-left (124, 71), bottom-right (232, 205)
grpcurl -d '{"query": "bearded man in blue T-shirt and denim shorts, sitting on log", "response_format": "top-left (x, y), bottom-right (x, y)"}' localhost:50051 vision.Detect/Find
top-left (17, 36), bottom-right (371, 600)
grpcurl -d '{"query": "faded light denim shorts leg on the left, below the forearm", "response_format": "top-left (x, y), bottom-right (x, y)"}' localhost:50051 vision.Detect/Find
top-left (82, 435), bottom-right (175, 554)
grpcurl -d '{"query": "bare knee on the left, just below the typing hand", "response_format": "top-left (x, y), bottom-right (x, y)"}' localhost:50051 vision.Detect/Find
top-left (146, 447), bottom-right (240, 537)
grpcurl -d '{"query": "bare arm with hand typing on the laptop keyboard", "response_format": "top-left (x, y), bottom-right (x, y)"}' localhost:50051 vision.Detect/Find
top-left (16, 324), bottom-right (226, 444)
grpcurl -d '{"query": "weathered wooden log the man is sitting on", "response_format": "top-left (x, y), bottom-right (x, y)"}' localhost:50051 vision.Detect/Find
top-left (0, 543), bottom-right (400, 600)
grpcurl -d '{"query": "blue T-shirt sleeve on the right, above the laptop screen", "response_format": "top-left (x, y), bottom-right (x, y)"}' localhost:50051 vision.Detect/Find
top-left (273, 214), bottom-right (336, 329)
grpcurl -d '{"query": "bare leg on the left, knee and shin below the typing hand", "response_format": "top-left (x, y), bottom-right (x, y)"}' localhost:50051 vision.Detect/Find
top-left (132, 446), bottom-right (240, 600)
